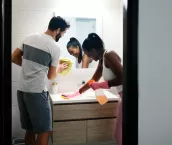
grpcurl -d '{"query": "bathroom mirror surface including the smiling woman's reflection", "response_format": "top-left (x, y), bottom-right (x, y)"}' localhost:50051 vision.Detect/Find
top-left (58, 17), bottom-right (97, 68)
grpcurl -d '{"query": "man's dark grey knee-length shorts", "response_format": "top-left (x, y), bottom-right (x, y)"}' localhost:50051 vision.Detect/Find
top-left (17, 91), bottom-right (52, 134)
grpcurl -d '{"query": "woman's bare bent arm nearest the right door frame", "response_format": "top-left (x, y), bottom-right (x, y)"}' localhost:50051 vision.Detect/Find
top-left (105, 51), bottom-right (123, 87)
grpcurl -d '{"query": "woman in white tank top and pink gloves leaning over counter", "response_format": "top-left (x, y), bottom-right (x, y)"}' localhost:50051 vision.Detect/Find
top-left (64, 33), bottom-right (123, 145)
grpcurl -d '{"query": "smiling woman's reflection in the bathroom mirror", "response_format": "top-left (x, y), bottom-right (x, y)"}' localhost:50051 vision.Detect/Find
top-left (66, 37), bottom-right (97, 68)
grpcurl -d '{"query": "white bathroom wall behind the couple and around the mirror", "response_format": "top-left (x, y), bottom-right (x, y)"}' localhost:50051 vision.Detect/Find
top-left (12, 0), bottom-right (122, 137)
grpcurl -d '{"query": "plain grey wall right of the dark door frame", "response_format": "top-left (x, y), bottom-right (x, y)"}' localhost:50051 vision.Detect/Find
top-left (138, 0), bottom-right (172, 145)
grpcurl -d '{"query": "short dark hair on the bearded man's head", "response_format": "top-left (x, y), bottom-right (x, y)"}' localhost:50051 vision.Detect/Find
top-left (48, 16), bottom-right (70, 32)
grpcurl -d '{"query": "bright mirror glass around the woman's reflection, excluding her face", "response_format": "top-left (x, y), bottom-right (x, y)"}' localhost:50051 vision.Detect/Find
top-left (55, 15), bottom-right (102, 69)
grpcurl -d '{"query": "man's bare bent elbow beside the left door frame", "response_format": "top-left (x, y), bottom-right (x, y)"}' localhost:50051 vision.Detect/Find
top-left (12, 48), bottom-right (23, 66)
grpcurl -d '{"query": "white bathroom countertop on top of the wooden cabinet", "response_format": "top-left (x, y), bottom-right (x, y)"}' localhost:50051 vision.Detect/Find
top-left (50, 90), bottom-right (119, 104)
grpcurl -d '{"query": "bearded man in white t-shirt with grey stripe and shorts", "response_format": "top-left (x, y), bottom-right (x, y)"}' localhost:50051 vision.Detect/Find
top-left (12, 16), bottom-right (70, 145)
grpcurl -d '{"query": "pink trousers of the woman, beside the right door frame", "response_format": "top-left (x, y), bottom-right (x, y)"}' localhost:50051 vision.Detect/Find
top-left (115, 92), bottom-right (122, 145)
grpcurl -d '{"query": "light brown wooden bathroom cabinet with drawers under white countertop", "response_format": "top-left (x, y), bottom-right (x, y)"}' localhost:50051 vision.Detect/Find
top-left (53, 100), bottom-right (118, 145)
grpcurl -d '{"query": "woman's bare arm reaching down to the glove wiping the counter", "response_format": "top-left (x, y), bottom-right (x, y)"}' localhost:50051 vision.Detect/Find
top-left (79, 60), bottom-right (103, 93)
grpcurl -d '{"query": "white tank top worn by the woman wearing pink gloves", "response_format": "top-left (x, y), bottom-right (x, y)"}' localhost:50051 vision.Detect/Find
top-left (102, 51), bottom-right (122, 94)
